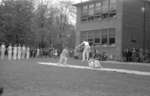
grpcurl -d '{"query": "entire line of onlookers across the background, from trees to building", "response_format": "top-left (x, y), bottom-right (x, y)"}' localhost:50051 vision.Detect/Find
top-left (0, 43), bottom-right (150, 62)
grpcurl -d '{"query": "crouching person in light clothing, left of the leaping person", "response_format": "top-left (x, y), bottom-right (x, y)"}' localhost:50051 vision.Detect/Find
top-left (59, 47), bottom-right (69, 64)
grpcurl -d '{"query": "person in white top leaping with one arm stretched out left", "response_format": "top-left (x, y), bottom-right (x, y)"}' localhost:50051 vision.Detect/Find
top-left (76, 41), bottom-right (90, 61)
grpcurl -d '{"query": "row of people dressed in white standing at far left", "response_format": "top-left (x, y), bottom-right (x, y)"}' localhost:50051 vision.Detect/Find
top-left (0, 44), bottom-right (30, 60)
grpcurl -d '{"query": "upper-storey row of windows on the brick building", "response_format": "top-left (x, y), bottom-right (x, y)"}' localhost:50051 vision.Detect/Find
top-left (81, 0), bottom-right (117, 21)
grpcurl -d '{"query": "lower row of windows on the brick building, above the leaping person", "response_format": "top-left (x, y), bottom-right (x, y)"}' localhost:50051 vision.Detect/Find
top-left (80, 28), bottom-right (116, 45)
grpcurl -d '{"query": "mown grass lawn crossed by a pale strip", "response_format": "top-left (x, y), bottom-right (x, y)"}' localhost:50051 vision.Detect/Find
top-left (0, 59), bottom-right (150, 96)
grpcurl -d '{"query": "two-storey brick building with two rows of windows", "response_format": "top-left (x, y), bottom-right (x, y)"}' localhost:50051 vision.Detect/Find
top-left (74, 0), bottom-right (150, 59)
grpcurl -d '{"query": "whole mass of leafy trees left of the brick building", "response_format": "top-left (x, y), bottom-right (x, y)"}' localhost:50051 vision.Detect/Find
top-left (0, 0), bottom-right (75, 48)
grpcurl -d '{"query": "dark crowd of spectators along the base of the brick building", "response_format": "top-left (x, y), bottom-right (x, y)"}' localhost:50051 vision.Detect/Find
top-left (74, 45), bottom-right (150, 63)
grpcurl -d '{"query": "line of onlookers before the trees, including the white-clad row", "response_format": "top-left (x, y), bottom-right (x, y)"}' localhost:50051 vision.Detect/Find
top-left (0, 43), bottom-right (73, 60)
